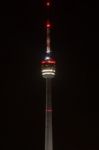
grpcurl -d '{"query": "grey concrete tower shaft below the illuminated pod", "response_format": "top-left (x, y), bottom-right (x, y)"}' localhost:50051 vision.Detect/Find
top-left (45, 78), bottom-right (53, 150)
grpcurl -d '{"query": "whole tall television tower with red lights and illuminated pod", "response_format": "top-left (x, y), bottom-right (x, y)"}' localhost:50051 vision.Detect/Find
top-left (41, 0), bottom-right (56, 150)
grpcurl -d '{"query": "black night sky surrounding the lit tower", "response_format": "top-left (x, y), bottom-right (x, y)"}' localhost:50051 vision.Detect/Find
top-left (0, 0), bottom-right (99, 150)
